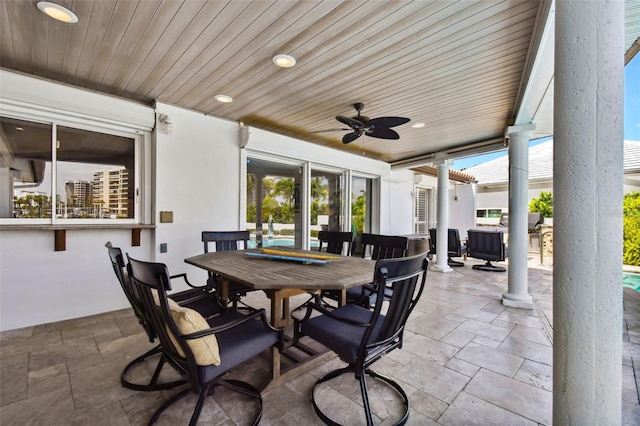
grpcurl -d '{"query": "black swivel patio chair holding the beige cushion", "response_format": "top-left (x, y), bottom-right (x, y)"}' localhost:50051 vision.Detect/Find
top-left (127, 255), bottom-right (283, 425)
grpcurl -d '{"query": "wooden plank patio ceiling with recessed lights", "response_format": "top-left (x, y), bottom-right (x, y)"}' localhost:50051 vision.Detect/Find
top-left (0, 0), bottom-right (543, 162)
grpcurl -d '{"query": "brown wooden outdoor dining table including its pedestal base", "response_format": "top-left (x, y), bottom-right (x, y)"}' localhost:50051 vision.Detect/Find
top-left (185, 249), bottom-right (375, 388)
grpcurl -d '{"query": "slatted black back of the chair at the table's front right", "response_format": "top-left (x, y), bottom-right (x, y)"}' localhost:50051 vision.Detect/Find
top-left (358, 253), bottom-right (429, 370)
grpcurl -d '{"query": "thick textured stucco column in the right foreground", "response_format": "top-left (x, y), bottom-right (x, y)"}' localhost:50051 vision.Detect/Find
top-left (553, 1), bottom-right (624, 425)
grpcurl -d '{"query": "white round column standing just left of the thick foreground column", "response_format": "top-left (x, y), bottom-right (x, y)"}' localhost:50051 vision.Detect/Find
top-left (502, 124), bottom-right (535, 309)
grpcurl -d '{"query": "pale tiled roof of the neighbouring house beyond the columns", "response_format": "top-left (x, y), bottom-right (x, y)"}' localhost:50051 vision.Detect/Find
top-left (464, 139), bottom-right (640, 185)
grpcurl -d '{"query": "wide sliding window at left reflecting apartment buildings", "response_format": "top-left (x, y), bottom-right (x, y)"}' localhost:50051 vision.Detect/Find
top-left (0, 117), bottom-right (137, 223)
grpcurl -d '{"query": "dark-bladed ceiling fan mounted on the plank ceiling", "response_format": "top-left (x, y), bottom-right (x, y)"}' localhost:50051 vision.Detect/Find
top-left (314, 102), bottom-right (410, 144)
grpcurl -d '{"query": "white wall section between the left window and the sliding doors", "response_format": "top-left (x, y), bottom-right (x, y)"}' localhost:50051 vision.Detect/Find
top-left (153, 103), bottom-right (240, 288)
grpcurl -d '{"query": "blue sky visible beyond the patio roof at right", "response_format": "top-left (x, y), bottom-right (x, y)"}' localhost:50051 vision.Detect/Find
top-left (451, 55), bottom-right (640, 170)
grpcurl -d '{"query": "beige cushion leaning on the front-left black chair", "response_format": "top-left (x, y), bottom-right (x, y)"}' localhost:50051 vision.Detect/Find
top-left (167, 304), bottom-right (220, 365)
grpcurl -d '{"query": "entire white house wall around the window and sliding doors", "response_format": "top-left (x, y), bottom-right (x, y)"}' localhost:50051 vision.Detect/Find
top-left (0, 71), bottom-right (413, 331)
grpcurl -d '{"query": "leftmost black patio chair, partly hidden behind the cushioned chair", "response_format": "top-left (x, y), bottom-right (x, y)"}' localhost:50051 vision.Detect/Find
top-left (105, 241), bottom-right (220, 391)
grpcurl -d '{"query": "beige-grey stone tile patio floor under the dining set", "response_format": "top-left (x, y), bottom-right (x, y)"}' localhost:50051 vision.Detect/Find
top-left (0, 256), bottom-right (640, 426)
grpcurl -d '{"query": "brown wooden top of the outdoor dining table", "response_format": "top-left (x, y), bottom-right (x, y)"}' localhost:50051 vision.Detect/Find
top-left (184, 249), bottom-right (375, 290)
